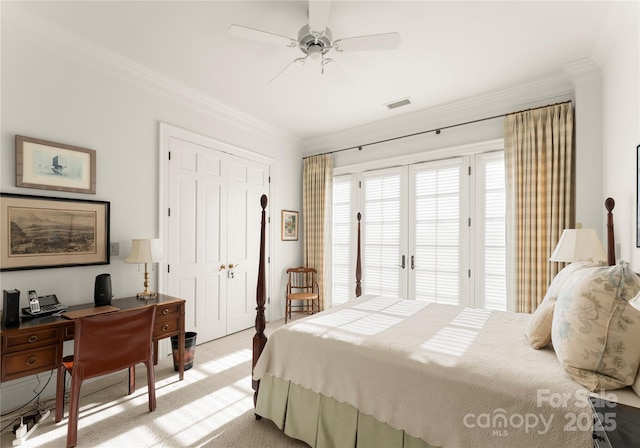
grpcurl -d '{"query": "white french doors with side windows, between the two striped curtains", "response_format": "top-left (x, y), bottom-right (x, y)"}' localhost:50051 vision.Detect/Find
top-left (332, 151), bottom-right (506, 309)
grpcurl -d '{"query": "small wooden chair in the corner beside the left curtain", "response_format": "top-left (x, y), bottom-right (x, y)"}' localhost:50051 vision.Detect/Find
top-left (284, 266), bottom-right (320, 324)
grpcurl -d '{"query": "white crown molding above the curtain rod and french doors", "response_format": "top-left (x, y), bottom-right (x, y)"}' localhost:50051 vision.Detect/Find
top-left (303, 73), bottom-right (575, 155)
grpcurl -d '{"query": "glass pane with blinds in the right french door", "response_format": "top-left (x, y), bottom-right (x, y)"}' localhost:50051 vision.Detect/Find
top-left (410, 159), bottom-right (461, 305)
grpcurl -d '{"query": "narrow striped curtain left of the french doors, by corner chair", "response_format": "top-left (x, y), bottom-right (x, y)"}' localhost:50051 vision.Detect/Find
top-left (302, 154), bottom-right (333, 310)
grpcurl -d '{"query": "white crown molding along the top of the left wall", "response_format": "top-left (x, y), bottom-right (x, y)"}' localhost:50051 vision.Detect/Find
top-left (2, 2), bottom-right (300, 147)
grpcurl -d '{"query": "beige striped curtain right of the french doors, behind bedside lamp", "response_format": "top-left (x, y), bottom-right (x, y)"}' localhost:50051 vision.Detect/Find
top-left (504, 103), bottom-right (575, 313)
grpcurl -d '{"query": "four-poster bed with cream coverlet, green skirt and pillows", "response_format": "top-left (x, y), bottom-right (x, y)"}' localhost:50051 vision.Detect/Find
top-left (253, 196), bottom-right (640, 448)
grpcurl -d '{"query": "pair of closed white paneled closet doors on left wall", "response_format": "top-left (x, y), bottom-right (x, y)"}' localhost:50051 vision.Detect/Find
top-left (165, 128), bottom-right (269, 343)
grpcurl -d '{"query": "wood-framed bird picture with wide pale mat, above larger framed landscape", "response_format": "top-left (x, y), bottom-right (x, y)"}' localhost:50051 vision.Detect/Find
top-left (16, 135), bottom-right (96, 194)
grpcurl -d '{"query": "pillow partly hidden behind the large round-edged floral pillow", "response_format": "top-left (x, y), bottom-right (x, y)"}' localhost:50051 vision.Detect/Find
top-left (525, 261), bottom-right (597, 350)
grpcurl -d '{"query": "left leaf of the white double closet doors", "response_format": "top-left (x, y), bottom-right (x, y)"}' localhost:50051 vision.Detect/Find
top-left (167, 137), bottom-right (229, 343)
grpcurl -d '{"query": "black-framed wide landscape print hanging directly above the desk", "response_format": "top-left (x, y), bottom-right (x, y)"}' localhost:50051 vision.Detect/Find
top-left (0, 193), bottom-right (110, 271)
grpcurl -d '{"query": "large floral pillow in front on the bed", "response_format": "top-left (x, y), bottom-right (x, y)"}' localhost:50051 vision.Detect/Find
top-left (551, 262), bottom-right (640, 391)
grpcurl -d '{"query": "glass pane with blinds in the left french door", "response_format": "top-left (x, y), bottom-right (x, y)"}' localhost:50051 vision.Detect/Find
top-left (362, 170), bottom-right (405, 297)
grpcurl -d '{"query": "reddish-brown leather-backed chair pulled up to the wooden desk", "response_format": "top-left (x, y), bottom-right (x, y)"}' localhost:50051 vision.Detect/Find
top-left (56, 305), bottom-right (156, 447)
